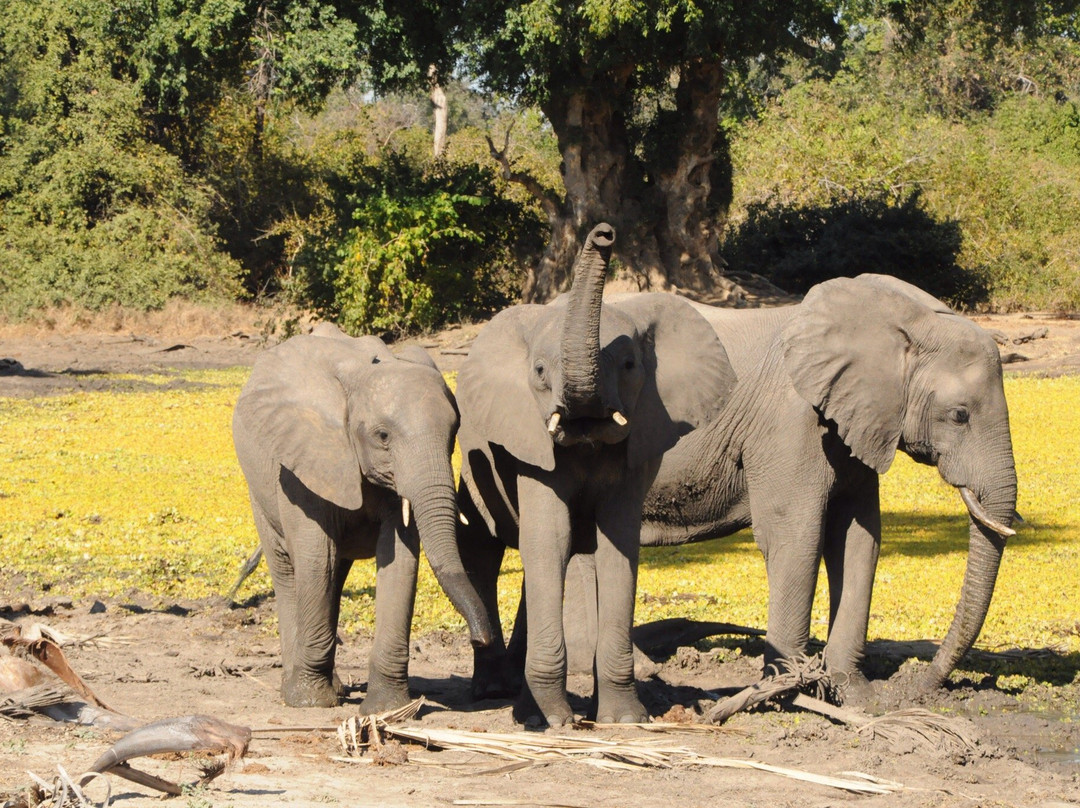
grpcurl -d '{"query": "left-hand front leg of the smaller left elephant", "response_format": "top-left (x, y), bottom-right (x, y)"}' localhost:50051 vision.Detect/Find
top-left (279, 517), bottom-right (340, 706)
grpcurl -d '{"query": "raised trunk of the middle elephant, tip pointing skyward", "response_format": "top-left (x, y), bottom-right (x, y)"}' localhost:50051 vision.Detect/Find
top-left (561, 225), bottom-right (615, 418)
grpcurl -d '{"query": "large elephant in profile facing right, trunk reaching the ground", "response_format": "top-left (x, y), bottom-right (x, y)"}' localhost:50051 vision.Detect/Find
top-left (642, 274), bottom-right (1016, 700)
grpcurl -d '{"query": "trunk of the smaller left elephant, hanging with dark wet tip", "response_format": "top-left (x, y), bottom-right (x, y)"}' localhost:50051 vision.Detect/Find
top-left (395, 441), bottom-right (492, 648)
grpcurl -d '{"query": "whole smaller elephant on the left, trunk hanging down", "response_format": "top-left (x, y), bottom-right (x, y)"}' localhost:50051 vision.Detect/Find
top-left (232, 326), bottom-right (491, 713)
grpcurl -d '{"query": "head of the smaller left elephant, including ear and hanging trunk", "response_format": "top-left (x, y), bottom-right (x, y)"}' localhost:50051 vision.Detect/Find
top-left (234, 328), bottom-right (490, 645)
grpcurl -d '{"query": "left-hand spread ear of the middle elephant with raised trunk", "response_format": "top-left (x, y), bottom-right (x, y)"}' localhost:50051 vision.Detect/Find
top-left (457, 305), bottom-right (555, 471)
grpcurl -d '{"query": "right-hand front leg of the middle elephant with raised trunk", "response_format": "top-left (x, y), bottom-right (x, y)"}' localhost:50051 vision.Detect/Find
top-left (596, 498), bottom-right (649, 724)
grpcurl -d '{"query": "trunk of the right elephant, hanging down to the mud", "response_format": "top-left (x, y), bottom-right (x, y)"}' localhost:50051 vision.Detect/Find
top-left (920, 446), bottom-right (1016, 691)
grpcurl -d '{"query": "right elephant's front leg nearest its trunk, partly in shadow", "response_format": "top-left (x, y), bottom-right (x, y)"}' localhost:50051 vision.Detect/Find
top-left (824, 474), bottom-right (881, 701)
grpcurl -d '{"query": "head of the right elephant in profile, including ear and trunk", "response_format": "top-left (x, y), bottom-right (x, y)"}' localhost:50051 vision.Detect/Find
top-left (782, 274), bottom-right (1016, 689)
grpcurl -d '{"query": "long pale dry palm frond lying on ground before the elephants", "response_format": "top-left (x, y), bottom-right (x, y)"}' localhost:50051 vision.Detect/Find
top-left (338, 701), bottom-right (897, 794)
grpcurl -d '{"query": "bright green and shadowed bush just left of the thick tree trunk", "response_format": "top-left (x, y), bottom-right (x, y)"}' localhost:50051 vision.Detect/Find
top-left (325, 157), bottom-right (538, 334)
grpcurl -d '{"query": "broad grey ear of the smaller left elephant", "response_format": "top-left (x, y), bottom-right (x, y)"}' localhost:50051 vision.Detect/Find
top-left (235, 336), bottom-right (394, 509)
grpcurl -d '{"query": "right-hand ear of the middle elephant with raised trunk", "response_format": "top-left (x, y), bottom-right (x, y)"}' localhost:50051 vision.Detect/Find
top-left (605, 292), bottom-right (735, 467)
